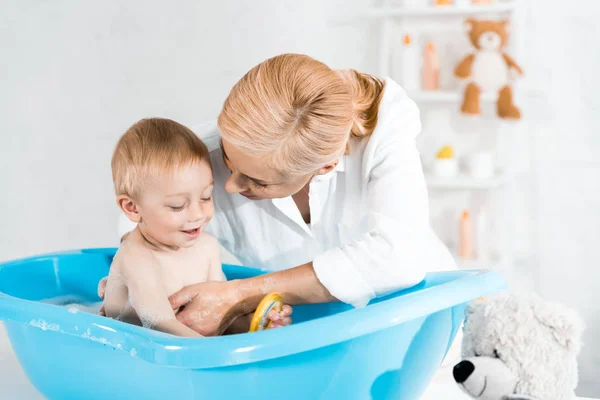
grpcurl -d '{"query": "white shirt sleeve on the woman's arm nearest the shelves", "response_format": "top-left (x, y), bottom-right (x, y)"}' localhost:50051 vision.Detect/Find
top-left (313, 91), bottom-right (449, 307)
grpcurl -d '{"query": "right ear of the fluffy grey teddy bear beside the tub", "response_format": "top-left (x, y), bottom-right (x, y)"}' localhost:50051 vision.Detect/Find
top-left (535, 304), bottom-right (585, 354)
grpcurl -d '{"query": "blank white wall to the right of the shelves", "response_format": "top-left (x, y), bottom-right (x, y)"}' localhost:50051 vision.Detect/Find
top-left (527, 0), bottom-right (600, 397)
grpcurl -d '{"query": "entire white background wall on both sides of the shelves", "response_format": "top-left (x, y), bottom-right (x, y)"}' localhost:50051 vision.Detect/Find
top-left (0, 0), bottom-right (600, 396)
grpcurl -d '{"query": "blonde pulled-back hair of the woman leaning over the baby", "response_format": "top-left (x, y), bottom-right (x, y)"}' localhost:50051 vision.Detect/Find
top-left (218, 54), bottom-right (385, 176)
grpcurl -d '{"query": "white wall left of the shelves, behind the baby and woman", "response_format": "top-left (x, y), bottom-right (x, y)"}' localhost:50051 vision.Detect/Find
top-left (0, 0), bottom-right (376, 259)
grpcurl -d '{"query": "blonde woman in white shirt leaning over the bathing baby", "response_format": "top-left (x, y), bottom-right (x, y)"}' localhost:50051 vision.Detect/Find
top-left (115, 54), bottom-right (454, 335)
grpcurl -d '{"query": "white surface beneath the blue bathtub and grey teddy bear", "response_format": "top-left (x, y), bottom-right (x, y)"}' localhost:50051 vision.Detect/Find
top-left (0, 324), bottom-right (592, 400)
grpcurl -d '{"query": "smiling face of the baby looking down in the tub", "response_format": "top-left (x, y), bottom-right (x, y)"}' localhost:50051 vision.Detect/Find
top-left (137, 162), bottom-right (215, 247)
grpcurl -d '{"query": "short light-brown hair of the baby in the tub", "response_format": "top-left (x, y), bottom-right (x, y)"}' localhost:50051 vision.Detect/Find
top-left (111, 118), bottom-right (210, 197)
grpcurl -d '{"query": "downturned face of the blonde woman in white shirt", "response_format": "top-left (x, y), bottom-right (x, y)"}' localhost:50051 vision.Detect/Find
top-left (221, 139), bottom-right (326, 200)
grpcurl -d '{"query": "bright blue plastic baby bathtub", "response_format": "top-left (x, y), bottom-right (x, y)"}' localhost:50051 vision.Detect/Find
top-left (0, 249), bottom-right (505, 400)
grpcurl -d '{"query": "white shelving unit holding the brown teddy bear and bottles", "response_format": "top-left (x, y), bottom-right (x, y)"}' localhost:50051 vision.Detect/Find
top-left (362, 0), bottom-right (525, 281)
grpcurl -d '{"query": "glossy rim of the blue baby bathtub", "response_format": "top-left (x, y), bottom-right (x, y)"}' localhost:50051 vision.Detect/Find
top-left (0, 248), bottom-right (507, 369)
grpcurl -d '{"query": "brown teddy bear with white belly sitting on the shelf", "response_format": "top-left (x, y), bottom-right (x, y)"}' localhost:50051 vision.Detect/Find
top-left (454, 18), bottom-right (523, 119)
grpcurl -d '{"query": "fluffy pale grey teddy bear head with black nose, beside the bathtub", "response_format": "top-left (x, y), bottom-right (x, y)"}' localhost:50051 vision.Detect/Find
top-left (453, 293), bottom-right (583, 400)
